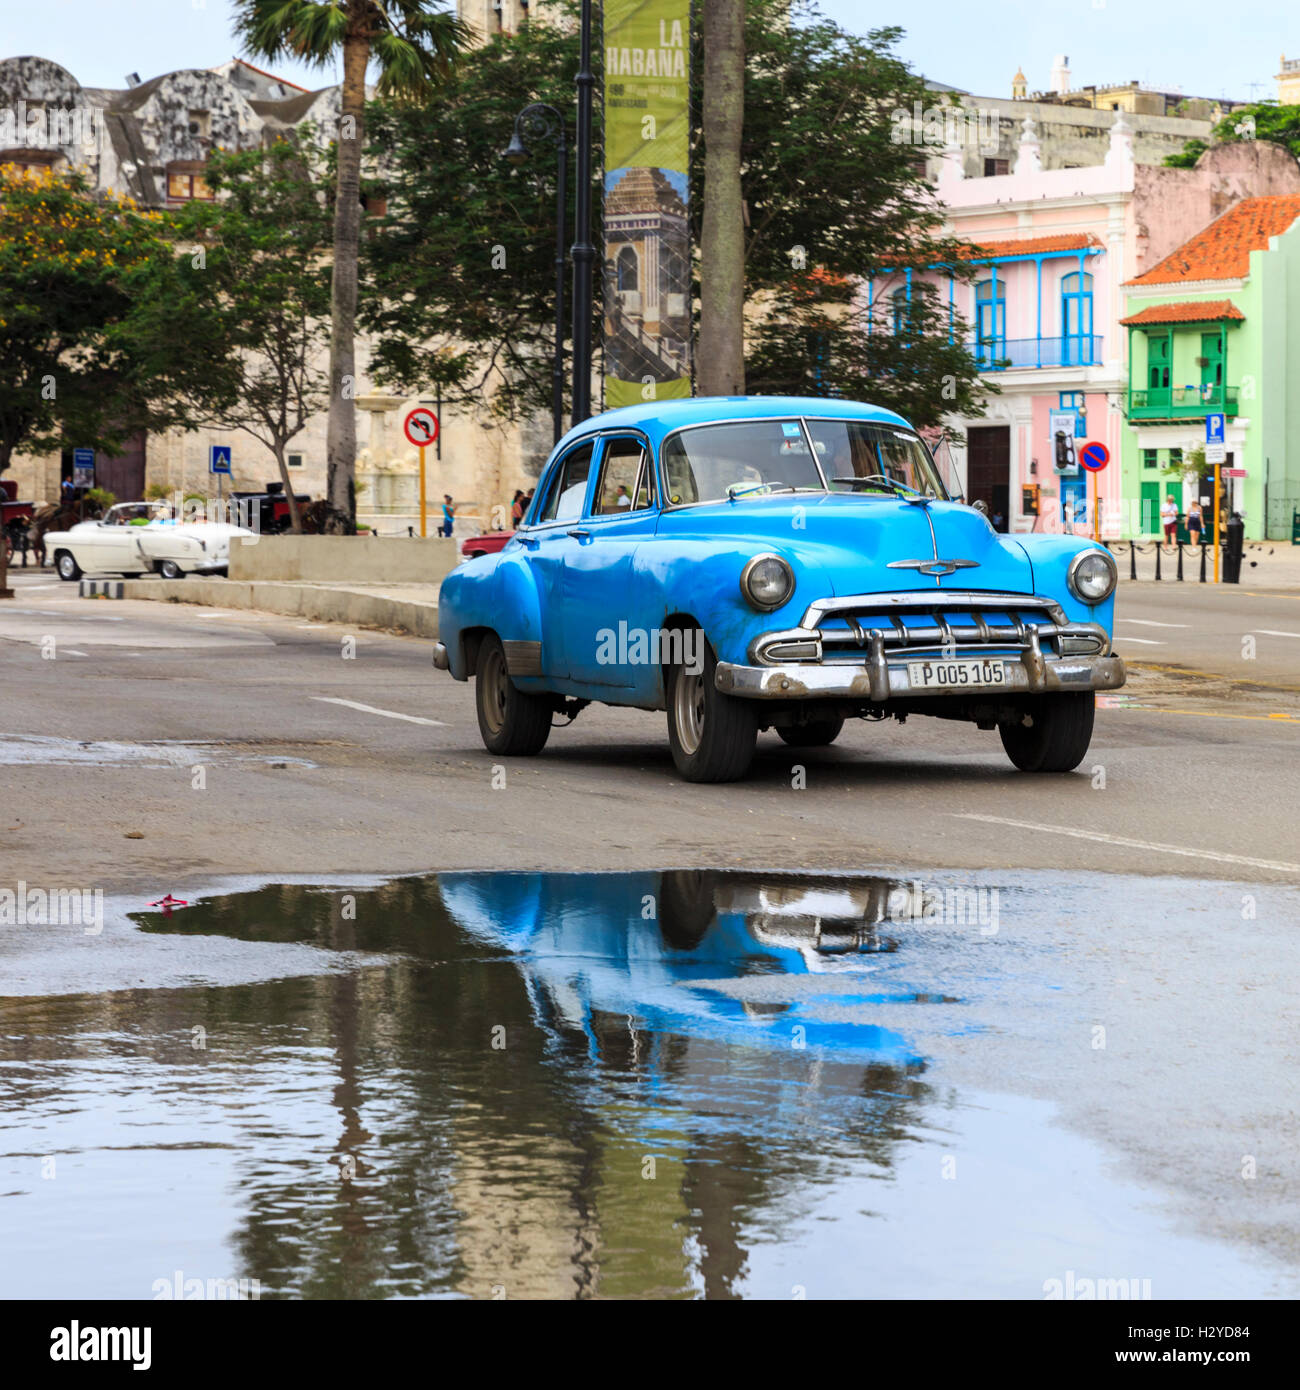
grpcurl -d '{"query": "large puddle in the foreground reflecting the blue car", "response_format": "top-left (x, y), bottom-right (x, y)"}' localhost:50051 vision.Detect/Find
top-left (0, 872), bottom-right (1295, 1298)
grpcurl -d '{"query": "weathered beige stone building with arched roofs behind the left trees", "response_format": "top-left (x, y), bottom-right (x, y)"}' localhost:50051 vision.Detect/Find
top-left (0, 44), bottom-right (551, 535)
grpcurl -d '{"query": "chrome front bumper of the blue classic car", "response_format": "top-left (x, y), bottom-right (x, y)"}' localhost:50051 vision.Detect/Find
top-left (715, 649), bottom-right (1128, 705)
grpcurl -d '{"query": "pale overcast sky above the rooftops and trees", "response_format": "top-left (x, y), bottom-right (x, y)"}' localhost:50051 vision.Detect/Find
top-left (0, 0), bottom-right (1300, 100)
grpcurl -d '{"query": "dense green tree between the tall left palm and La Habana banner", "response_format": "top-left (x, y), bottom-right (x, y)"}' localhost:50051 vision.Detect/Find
top-left (361, 24), bottom-right (583, 418)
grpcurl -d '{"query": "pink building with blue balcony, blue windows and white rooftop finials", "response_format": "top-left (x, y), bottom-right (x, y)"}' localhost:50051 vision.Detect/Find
top-left (868, 111), bottom-right (1300, 538)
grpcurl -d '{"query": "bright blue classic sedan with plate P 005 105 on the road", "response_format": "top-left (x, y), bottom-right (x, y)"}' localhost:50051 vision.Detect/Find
top-left (434, 396), bottom-right (1125, 781)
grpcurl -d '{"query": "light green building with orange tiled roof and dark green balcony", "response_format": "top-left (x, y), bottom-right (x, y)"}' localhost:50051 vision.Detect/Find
top-left (1121, 195), bottom-right (1300, 539)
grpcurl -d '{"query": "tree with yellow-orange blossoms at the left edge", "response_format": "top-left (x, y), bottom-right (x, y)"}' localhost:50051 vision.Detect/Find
top-left (0, 165), bottom-right (206, 594)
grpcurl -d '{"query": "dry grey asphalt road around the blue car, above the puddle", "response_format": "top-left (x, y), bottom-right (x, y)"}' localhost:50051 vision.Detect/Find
top-left (0, 571), bottom-right (1300, 894)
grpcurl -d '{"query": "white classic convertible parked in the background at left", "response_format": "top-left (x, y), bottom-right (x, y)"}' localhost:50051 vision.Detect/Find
top-left (44, 502), bottom-right (254, 580)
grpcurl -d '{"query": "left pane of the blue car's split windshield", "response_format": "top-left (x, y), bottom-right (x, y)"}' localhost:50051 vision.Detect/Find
top-left (663, 420), bottom-right (824, 506)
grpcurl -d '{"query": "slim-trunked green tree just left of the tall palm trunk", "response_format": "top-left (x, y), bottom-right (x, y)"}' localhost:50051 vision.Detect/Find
top-left (163, 135), bottom-right (334, 531)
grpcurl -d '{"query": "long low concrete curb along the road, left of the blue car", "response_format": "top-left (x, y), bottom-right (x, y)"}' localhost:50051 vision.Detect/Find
top-left (122, 577), bottom-right (438, 638)
